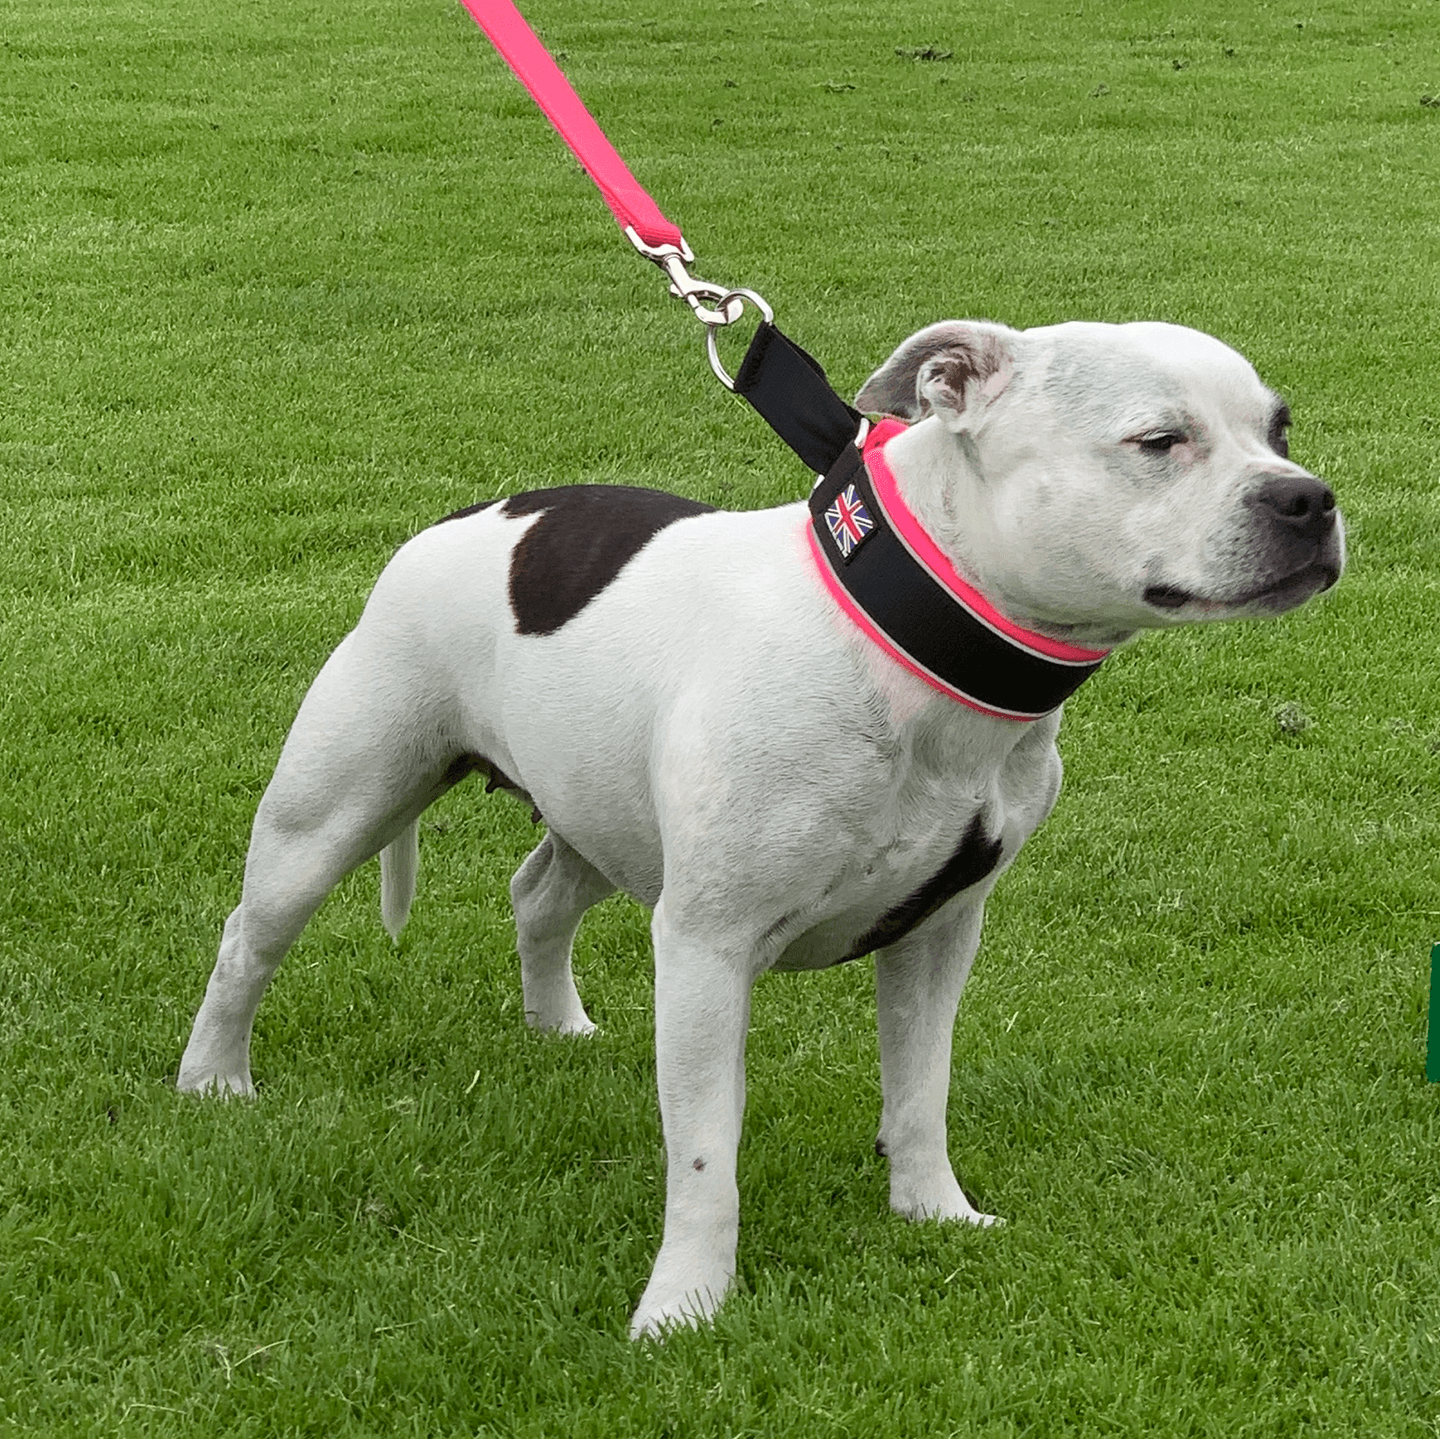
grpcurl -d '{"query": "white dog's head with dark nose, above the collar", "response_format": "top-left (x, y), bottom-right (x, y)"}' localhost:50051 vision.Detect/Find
top-left (857, 321), bottom-right (1345, 642)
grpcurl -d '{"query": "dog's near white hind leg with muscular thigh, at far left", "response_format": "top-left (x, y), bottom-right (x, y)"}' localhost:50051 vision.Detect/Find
top-left (177, 631), bottom-right (454, 1095)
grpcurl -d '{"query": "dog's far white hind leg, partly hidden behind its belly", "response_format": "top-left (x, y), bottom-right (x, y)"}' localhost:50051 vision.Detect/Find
top-left (510, 831), bottom-right (615, 1034)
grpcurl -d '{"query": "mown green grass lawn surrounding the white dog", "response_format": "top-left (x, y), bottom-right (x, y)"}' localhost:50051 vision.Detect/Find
top-left (0, 0), bottom-right (1440, 1439)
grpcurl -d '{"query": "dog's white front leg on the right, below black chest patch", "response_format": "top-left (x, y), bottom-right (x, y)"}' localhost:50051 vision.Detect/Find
top-left (876, 897), bottom-right (995, 1224)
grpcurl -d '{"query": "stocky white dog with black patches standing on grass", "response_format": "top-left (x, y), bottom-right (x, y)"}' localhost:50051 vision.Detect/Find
top-left (179, 321), bottom-right (1345, 1338)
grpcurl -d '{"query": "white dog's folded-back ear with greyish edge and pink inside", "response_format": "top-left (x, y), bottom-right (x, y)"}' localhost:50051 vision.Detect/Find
top-left (855, 320), bottom-right (1015, 432)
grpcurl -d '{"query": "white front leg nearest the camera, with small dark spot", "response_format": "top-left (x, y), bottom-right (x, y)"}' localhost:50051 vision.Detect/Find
top-left (631, 897), bottom-right (755, 1340)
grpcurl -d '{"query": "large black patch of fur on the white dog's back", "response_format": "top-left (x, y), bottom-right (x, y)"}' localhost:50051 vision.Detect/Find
top-left (504, 484), bottom-right (714, 635)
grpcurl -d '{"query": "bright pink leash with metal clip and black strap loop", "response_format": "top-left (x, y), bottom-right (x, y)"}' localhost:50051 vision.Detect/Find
top-left (461, 0), bottom-right (864, 474)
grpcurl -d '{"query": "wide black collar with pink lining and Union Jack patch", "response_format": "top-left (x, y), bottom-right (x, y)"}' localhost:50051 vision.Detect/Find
top-left (808, 419), bottom-right (1109, 720)
